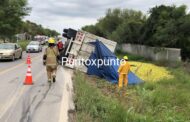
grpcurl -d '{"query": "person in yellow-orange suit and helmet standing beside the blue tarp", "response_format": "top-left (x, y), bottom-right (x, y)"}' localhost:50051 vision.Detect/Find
top-left (118, 56), bottom-right (130, 89)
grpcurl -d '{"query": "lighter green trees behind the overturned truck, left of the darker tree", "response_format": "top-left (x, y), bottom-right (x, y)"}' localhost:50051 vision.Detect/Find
top-left (82, 9), bottom-right (146, 43)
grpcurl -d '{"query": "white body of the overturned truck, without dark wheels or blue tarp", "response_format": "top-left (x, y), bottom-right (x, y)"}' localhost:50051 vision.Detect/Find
top-left (65, 30), bottom-right (117, 72)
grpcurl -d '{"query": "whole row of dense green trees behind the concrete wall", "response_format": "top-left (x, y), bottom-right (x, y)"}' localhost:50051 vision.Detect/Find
top-left (82, 5), bottom-right (190, 60)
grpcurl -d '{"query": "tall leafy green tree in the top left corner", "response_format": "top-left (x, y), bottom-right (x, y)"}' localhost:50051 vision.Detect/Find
top-left (0, 0), bottom-right (30, 39)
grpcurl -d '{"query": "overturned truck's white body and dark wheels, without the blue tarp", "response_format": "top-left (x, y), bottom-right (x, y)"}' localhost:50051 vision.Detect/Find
top-left (63, 29), bottom-right (117, 73)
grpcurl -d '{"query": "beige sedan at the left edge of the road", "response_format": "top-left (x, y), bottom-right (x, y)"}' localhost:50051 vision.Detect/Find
top-left (0, 43), bottom-right (22, 61)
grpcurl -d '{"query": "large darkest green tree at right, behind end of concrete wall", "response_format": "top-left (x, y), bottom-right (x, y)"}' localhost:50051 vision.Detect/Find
top-left (141, 5), bottom-right (190, 59)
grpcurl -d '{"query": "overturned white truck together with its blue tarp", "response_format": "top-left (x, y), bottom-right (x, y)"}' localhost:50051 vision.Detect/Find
top-left (62, 29), bottom-right (142, 84)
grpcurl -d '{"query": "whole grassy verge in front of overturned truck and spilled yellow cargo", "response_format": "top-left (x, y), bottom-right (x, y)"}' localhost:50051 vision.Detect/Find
top-left (74, 54), bottom-right (190, 122)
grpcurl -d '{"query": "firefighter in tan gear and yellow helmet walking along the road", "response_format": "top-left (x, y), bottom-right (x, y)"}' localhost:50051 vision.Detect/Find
top-left (43, 38), bottom-right (59, 83)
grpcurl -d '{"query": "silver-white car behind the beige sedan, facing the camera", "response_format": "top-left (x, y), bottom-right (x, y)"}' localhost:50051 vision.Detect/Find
top-left (26, 41), bottom-right (42, 53)
